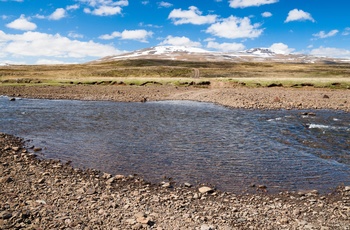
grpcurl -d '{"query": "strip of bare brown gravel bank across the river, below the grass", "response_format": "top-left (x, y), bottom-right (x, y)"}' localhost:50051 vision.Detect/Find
top-left (0, 82), bottom-right (350, 112)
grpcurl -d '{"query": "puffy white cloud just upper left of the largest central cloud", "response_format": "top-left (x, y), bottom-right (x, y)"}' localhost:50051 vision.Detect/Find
top-left (168, 6), bottom-right (217, 25)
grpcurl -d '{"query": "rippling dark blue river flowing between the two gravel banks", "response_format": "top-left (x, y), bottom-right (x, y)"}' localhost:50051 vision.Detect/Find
top-left (0, 97), bottom-right (350, 193)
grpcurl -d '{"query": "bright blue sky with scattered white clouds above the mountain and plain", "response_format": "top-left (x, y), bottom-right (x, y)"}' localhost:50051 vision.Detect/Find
top-left (0, 0), bottom-right (350, 64)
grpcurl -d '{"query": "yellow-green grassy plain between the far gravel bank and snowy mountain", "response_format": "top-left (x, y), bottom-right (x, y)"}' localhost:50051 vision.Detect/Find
top-left (0, 59), bottom-right (350, 89)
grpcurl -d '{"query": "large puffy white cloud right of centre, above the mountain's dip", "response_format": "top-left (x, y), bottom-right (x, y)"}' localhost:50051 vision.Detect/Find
top-left (206, 16), bottom-right (263, 39)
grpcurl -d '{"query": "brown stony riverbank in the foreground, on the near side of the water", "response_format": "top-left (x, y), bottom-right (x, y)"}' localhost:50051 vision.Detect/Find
top-left (0, 134), bottom-right (350, 230)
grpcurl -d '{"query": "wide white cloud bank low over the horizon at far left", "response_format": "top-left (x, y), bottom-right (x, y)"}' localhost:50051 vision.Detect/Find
top-left (0, 30), bottom-right (121, 63)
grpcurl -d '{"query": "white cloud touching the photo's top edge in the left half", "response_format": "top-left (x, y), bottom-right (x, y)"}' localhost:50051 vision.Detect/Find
top-left (79, 0), bottom-right (129, 16)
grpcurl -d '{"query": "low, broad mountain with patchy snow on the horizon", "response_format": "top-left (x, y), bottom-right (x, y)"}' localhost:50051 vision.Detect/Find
top-left (97, 46), bottom-right (349, 63)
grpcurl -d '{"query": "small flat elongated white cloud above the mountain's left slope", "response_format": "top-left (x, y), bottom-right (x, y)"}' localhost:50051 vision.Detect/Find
top-left (99, 30), bottom-right (153, 42)
